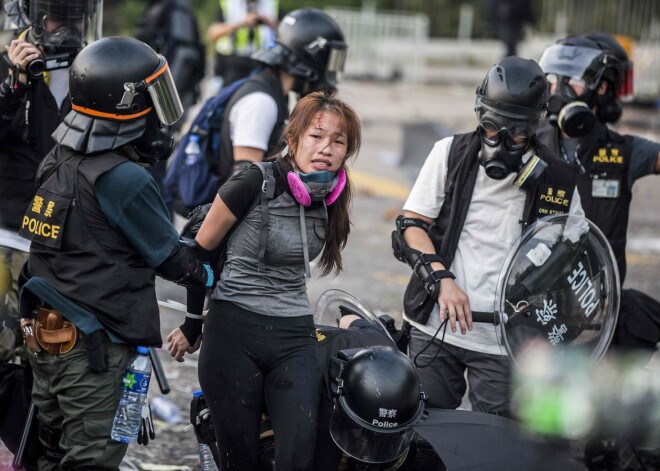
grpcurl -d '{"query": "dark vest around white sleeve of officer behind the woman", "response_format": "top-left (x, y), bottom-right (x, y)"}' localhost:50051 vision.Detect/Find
top-left (217, 66), bottom-right (289, 185)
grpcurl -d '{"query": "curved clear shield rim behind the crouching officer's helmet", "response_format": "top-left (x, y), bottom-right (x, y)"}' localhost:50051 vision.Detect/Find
top-left (314, 289), bottom-right (394, 342)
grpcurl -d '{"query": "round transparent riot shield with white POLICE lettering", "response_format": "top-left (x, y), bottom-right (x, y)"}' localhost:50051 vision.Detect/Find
top-left (495, 215), bottom-right (620, 363)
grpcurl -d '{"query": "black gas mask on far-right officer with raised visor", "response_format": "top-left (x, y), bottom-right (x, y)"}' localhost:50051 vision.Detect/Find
top-left (547, 74), bottom-right (596, 138)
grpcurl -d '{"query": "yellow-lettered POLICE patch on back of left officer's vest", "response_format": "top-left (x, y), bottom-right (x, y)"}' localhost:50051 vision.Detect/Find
top-left (18, 188), bottom-right (72, 249)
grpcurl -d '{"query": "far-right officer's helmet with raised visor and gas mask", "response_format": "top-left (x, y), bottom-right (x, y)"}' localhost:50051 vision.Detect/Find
top-left (539, 33), bottom-right (632, 133)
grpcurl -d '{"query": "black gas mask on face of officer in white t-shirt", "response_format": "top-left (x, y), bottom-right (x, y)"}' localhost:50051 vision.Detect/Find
top-left (478, 111), bottom-right (547, 189)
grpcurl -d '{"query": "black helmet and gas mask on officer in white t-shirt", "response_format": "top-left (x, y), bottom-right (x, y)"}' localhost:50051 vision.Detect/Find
top-left (475, 56), bottom-right (549, 186)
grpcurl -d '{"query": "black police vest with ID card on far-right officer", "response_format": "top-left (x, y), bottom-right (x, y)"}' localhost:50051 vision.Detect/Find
top-left (537, 123), bottom-right (632, 284)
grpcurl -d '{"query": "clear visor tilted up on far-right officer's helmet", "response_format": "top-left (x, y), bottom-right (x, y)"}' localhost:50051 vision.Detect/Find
top-left (539, 44), bottom-right (607, 90)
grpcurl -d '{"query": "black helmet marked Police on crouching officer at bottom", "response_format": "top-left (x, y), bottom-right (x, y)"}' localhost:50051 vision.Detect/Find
top-left (330, 347), bottom-right (426, 463)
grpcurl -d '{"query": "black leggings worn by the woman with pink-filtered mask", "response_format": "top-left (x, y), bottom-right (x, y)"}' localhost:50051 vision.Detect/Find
top-left (198, 301), bottom-right (321, 471)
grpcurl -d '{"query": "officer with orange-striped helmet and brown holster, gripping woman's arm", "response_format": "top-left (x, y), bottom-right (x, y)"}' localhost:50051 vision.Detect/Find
top-left (20, 37), bottom-right (213, 469)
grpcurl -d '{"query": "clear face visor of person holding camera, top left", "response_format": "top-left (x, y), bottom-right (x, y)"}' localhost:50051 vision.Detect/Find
top-left (29, 0), bottom-right (103, 55)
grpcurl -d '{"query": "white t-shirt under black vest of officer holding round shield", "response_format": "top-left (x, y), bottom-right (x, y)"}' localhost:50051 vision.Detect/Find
top-left (403, 137), bottom-right (584, 355)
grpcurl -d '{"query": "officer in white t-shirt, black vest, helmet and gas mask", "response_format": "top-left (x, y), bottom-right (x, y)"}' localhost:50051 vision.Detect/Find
top-left (392, 56), bottom-right (582, 415)
